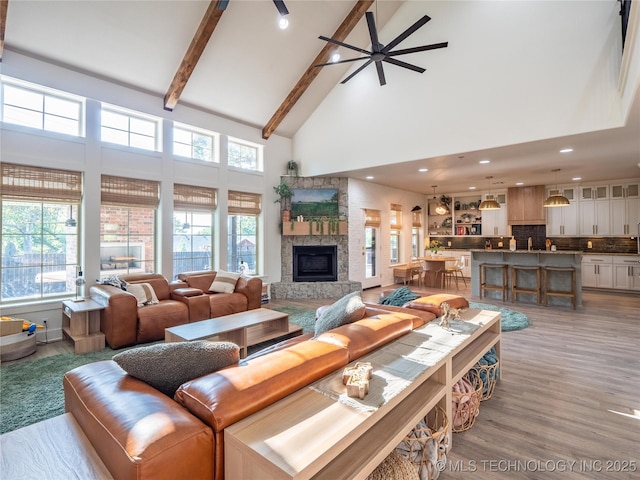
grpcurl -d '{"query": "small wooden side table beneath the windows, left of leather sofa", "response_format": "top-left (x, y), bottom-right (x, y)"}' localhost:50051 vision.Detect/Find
top-left (62, 298), bottom-right (104, 353)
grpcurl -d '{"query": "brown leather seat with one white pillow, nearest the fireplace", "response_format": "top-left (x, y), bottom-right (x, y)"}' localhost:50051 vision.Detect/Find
top-left (172, 270), bottom-right (262, 322)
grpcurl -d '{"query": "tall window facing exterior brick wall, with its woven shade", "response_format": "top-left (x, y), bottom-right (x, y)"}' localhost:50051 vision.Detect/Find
top-left (100, 175), bottom-right (159, 278)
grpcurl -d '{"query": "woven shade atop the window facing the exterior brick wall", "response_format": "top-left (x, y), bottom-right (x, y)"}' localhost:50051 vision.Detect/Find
top-left (100, 175), bottom-right (160, 208)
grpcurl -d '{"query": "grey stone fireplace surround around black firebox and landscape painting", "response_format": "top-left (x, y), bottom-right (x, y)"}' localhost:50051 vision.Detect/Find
top-left (271, 177), bottom-right (362, 299)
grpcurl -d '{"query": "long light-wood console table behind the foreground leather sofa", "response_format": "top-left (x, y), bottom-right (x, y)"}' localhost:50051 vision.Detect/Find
top-left (224, 309), bottom-right (501, 480)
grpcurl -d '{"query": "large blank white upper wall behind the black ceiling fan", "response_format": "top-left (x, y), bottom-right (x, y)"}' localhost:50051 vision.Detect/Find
top-left (294, 0), bottom-right (624, 175)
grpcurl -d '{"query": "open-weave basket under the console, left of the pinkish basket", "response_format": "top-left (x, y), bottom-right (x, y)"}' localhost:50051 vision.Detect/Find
top-left (396, 405), bottom-right (449, 480)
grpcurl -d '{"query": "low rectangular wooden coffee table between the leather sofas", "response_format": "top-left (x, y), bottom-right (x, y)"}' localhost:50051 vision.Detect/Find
top-left (164, 308), bottom-right (302, 358)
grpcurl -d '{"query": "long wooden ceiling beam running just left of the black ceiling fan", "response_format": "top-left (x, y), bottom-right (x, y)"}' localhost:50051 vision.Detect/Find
top-left (262, 0), bottom-right (374, 140)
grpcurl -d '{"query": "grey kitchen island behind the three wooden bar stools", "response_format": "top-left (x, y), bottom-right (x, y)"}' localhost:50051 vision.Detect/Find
top-left (471, 249), bottom-right (582, 306)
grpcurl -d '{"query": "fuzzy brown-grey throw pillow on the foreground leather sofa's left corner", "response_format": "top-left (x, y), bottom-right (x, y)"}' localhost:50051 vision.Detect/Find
top-left (113, 340), bottom-right (240, 397)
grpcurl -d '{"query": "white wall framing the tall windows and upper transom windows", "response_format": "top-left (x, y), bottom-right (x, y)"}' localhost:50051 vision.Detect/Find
top-left (0, 51), bottom-right (292, 340)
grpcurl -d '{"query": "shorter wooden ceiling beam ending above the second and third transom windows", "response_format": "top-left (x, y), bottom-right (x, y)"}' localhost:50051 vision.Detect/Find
top-left (164, 0), bottom-right (227, 111)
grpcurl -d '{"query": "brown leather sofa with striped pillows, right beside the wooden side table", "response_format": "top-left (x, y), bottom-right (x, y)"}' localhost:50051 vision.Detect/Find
top-left (89, 273), bottom-right (189, 348)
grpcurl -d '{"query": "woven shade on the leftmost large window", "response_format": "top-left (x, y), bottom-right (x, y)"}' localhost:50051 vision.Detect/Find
top-left (0, 163), bottom-right (82, 203)
